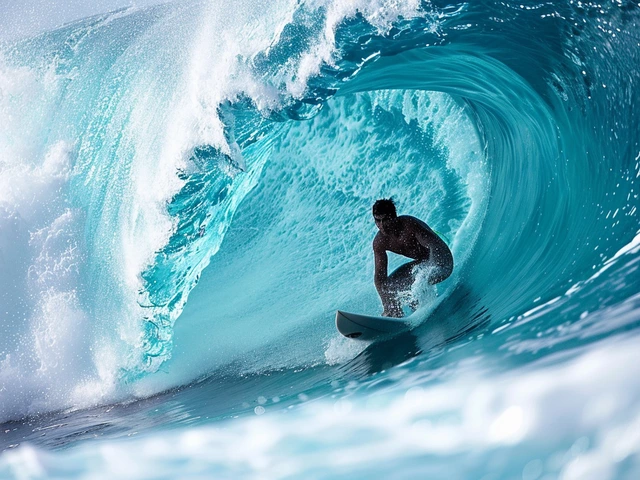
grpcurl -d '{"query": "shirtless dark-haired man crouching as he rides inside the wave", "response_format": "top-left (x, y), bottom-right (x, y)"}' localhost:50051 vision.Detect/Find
top-left (373, 198), bottom-right (453, 317)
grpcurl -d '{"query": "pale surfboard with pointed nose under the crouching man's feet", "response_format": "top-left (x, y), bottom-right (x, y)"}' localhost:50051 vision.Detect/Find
top-left (336, 310), bottom-right (411, 340)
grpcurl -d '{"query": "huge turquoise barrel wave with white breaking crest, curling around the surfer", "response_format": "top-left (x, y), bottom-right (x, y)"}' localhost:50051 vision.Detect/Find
top-left (0, 0), bottom-right (640, 440)
